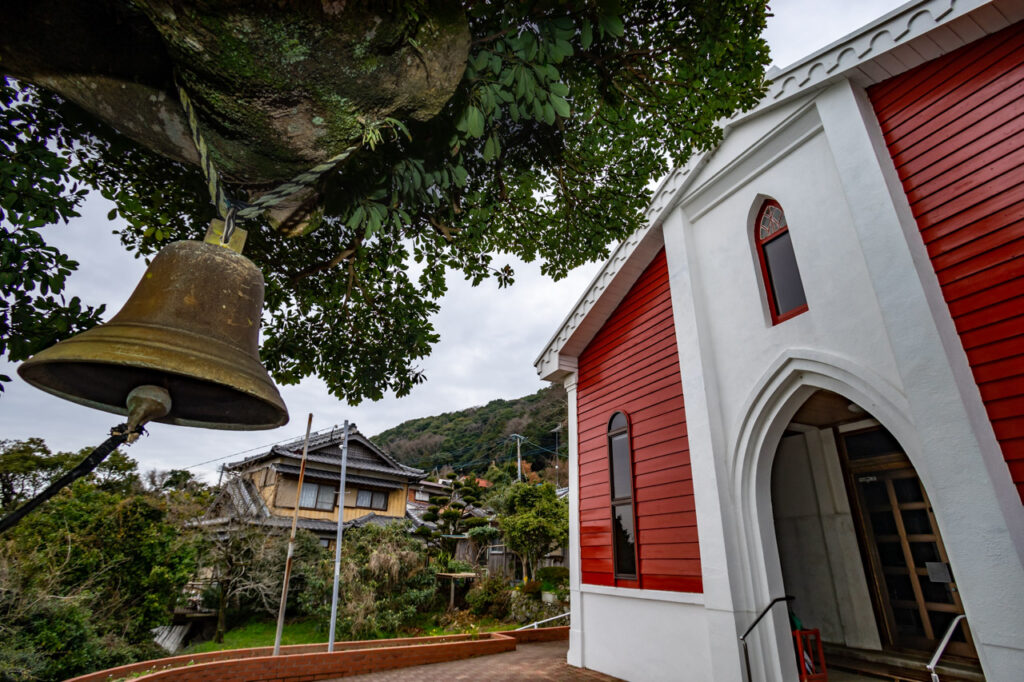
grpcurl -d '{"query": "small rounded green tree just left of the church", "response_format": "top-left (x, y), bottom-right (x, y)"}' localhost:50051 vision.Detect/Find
top-left (495, 483), bottom-right (569, 580)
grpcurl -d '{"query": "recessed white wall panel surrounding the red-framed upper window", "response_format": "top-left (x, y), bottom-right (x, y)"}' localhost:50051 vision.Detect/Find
top-left (684, 122), bottom-right (896, 433)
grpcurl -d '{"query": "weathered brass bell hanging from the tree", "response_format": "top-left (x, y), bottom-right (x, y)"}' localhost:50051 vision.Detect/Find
top-left (17, 242), bottom-right (288, 430)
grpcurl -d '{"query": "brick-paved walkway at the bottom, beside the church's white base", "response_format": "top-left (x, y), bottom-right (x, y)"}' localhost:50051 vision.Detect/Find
top-left (331, 640), bottom-right (617, 682)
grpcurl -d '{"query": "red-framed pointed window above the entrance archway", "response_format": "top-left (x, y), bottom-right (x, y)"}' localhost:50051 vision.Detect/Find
top-left (754, 199), bottom-right (807, 325)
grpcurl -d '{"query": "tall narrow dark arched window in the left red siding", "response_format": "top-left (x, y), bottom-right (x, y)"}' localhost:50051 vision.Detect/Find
top-left (608, 412), bottom-right (637, 580)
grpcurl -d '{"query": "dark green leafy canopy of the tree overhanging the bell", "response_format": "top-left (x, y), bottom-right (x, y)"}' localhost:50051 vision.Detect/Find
top-left (0, 0), bottom-right (768, 404)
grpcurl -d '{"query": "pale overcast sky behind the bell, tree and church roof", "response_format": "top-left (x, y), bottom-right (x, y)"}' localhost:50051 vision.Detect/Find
top-left (0, 0), bottom-right (904, 479)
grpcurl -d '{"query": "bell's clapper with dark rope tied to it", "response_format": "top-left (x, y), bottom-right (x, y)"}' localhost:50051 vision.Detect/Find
top-left (0, 386), bottom-right (171, 532)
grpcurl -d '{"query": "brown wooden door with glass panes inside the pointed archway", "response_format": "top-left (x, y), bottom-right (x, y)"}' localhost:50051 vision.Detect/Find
top-left (840, 427), bottom-right (977, 657)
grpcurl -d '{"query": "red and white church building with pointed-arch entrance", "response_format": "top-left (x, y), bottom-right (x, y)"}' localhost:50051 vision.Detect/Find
top-left (537, 0), bottom-right (1024, 680)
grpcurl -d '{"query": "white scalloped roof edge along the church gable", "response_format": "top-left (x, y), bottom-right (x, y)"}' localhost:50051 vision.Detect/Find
top-left (534, 0), bottom-right (1024, 381)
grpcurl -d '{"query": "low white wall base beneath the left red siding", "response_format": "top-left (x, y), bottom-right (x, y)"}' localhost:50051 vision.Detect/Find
top-left (582, 590), bottom-right (717, 682)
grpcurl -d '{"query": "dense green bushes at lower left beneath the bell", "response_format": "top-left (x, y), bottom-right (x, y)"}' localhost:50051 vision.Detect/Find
top-left (0, 438), bottom-right (197, 679)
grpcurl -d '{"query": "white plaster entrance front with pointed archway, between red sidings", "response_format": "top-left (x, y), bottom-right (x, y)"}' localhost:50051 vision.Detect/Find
top-left (663, 76), bottom-right (1024, 679)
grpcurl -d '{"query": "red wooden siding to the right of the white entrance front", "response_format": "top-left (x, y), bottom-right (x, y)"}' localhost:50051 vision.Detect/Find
top-left (868, 24), bottom-right (1024, 501)
